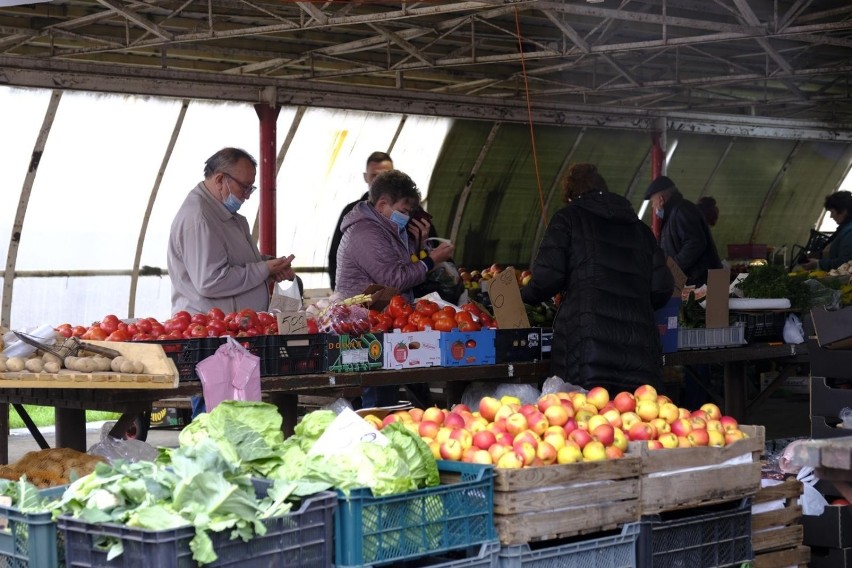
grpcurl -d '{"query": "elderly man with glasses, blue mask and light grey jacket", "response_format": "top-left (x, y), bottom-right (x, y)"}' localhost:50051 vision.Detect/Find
top-left (168, 148), bottom-right (295, 313)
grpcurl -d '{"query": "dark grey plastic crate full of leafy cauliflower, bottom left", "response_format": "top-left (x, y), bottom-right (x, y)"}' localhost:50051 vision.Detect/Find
top-left (57, 491), bottom-right (337, 568)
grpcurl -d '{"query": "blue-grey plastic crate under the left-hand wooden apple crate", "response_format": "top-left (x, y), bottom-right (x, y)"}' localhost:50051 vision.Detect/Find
top-left (499, 523), bottom-right (642, 568)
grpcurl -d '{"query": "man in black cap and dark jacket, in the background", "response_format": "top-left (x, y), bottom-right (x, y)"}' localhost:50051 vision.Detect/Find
top-left (645, 176), bottom-right (722, 286)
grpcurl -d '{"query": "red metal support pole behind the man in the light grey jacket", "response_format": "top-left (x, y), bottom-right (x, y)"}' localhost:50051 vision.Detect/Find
top-left (254, 103), bottom-right (281, 256)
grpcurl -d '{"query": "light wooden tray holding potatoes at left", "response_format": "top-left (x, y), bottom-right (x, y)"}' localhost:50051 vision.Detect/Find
top-left (0, 341), bottom-right (178, 389)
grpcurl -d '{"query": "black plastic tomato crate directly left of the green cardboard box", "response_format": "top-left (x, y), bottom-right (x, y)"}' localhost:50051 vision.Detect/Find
top-left (236, 333), bottom-right (326, 377)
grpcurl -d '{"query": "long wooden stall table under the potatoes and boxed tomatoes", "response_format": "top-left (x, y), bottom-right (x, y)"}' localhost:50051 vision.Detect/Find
top-left (0, 361), bottom-right (550, 463)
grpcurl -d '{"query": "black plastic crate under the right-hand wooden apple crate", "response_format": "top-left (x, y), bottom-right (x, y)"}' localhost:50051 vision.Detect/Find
top-left (637, 499), bottom-right (754, 568)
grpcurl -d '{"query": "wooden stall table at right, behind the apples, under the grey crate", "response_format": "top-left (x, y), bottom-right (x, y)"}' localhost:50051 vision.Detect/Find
top-left (663, 343), bottom-right (808, 422)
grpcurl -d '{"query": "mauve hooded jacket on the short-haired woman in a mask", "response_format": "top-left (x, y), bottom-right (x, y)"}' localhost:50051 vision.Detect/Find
top-left (335, 201), bottom-right (426, 302)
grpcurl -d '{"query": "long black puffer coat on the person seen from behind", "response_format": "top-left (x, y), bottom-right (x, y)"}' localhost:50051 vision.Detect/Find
top-left (522, 192), bottom-right (673, 393)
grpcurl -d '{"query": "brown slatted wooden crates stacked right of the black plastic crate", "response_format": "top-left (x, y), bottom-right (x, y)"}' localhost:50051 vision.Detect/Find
top-left (751, 479), bottom-right (810, 568)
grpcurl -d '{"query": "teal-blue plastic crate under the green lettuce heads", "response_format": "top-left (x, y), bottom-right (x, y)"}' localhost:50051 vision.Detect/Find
top-left (334, 460), bottom-right (496, 567)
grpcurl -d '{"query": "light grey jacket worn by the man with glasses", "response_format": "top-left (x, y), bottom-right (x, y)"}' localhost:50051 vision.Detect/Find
top-left (168, 183), bottom-right (269, 313)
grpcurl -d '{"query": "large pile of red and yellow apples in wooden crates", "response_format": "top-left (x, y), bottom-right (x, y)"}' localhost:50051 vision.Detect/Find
top-left (365, 385), bottom-right (746, 468)
